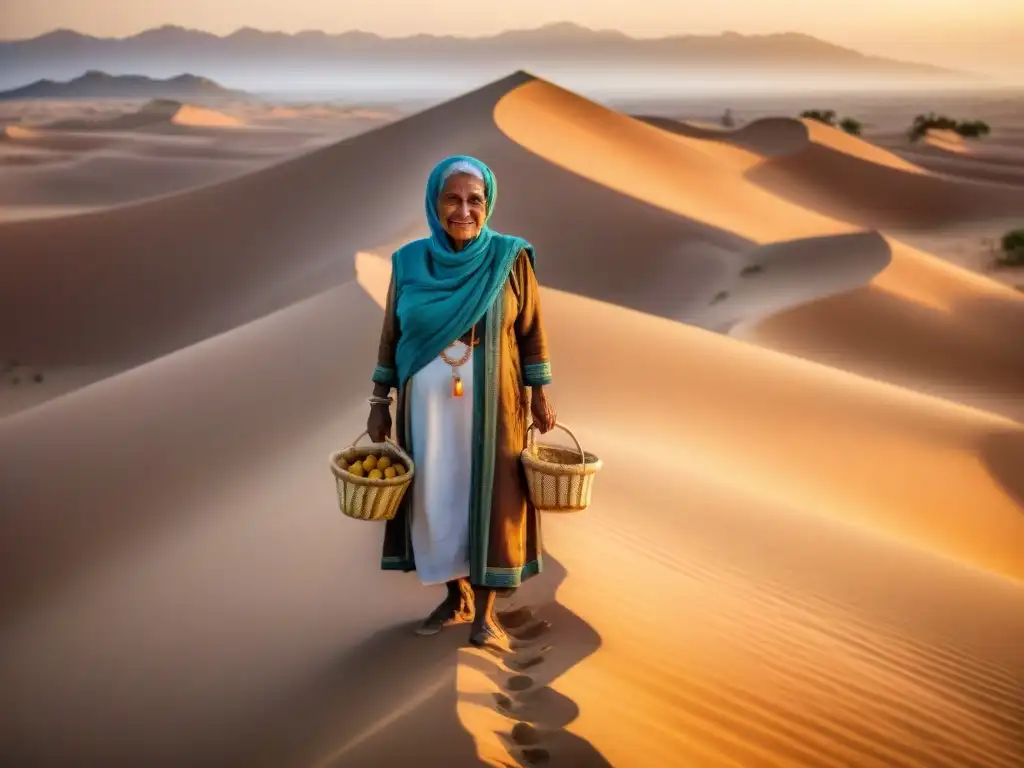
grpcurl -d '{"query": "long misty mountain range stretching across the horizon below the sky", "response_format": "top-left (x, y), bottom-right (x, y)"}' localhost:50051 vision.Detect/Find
top-left (0, 24), bottom-right (976, 87)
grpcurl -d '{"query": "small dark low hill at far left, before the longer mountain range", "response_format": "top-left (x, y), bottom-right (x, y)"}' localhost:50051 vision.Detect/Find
top-left (0, 70), bottom-right (247, 100)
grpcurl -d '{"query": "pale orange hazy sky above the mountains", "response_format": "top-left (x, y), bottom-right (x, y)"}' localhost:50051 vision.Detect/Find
top-left (6, 0), bottom-right (1024, 75)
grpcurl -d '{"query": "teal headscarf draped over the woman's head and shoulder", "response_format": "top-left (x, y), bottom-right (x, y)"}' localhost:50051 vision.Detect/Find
top-left (391, 155), bottom-right (534, 386)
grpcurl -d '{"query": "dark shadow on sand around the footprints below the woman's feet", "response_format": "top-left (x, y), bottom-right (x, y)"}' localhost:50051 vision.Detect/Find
top-left (204, 556), bottom-right (611, 768)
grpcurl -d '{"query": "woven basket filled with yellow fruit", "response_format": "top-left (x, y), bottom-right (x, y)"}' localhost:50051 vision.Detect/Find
top-left (331, 432), bottom-right (416, 520)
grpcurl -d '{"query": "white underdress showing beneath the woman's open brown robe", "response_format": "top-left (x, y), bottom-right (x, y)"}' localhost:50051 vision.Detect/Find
top-left (409, 341), bottom-right (473, 585)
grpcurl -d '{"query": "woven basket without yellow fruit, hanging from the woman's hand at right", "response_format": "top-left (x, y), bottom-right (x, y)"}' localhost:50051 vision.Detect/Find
top-left (520, 424), bottom-right (601, 512)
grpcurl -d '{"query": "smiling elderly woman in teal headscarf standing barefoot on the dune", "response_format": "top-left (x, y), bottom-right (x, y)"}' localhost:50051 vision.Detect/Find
top-left (367, 157), bottom-right (555, 645)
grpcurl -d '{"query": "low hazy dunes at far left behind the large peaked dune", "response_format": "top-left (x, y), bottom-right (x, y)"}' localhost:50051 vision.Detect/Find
top-left (0, 99), bottom-right (397, 220)
